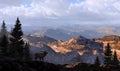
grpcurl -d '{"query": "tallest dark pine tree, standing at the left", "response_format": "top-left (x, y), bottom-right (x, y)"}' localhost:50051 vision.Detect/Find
top-left (9, 18), bottom-right (24, 60)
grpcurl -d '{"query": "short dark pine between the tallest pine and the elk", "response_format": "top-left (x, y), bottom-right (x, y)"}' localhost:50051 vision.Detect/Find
top-left (23, 43), bottom-right (31, 61)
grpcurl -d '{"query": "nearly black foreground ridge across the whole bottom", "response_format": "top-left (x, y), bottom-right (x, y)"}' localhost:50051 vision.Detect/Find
top-left (0, 58), bottom-right (120, 71)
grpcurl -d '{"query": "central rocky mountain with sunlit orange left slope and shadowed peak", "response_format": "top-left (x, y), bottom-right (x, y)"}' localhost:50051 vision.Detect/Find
top-left (48, 36), bottom-right (103, 63)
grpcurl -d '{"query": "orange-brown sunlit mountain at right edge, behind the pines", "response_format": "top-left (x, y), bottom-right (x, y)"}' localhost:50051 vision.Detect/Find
top-left (95, 35), bottom-right (120, 60)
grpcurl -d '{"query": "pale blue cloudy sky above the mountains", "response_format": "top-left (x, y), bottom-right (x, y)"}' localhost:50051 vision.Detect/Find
top-left (0, 0), bottom-right (120, 25)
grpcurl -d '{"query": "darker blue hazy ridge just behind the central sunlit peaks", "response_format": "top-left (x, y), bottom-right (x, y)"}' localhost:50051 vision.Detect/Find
top-left (33, 27), bottom-right (103, 40)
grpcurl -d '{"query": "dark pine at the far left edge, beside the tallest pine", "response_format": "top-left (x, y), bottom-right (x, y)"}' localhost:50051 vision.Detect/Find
top-left (0, 21), bottom-right (9, 56)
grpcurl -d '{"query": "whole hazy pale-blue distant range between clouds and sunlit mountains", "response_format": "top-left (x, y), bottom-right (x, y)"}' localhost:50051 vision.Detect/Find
top-left (24, 24), bottom-right (120, 40)
